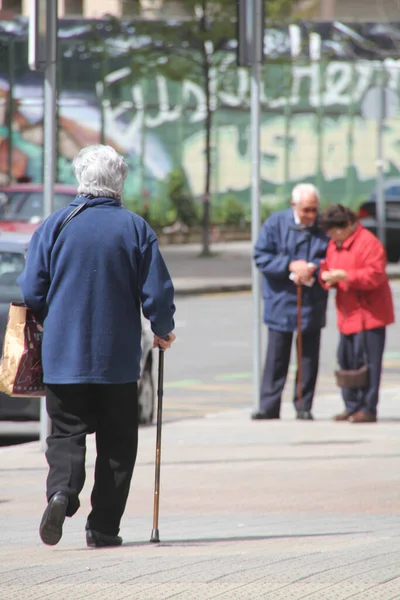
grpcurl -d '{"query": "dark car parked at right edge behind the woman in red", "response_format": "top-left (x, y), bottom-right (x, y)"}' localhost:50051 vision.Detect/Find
top-left (358, 177), bottom-right (400, 262)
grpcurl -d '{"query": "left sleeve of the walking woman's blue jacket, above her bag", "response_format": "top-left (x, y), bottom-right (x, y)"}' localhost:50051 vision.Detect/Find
top-left (18, 227), bottom-right (51, 318)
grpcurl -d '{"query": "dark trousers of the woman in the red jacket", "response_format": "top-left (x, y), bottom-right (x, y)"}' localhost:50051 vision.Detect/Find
top-left (338, 327), bottom-right (386, 416)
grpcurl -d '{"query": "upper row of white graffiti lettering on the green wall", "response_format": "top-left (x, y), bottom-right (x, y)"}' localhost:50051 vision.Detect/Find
top-left (96, 55), bottom-right (400, 129)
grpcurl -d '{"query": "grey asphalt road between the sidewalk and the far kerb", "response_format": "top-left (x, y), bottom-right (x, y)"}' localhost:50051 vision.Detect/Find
top-left (0, 283), bottom-right (400, 445)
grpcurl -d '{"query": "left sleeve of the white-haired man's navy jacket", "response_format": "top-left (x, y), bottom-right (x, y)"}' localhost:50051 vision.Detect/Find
top-left (254, 219), bottom-right (290, 279)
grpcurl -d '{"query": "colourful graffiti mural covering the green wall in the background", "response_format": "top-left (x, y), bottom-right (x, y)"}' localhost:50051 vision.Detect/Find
top-left (0, 57), bottom-right (400, 202)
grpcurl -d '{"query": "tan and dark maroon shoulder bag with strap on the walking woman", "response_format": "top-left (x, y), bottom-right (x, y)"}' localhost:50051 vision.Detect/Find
top-left (0, 201), bottom-right (88, 397)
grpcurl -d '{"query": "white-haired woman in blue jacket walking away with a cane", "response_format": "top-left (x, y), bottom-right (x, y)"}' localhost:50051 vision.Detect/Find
top-left (19, 145), bottom-right (175, 546)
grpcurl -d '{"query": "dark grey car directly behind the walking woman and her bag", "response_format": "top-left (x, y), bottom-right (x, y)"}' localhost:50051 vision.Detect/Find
top-left (0, 233), bottom-right (155, 424)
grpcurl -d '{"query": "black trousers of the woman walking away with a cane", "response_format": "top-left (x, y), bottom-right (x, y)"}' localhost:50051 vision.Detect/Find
top-left (46, 382), bottom-right (139, 535)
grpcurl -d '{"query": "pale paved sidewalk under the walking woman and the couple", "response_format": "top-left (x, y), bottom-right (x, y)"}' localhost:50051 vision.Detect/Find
top-left (0, 388), bottom-right (400, 600)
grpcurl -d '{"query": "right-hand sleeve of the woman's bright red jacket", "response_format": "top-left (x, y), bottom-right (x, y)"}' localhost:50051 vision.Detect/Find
top-left (340, 240), bottom-right (387, 291)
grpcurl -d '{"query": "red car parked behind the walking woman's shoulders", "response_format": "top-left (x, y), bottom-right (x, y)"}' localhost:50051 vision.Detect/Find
top-left (0, 183), bottom-right (76, 233)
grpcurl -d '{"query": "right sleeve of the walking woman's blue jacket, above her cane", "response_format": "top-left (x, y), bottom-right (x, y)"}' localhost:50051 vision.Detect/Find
top-left (139, 235), bottom-right (175, 337)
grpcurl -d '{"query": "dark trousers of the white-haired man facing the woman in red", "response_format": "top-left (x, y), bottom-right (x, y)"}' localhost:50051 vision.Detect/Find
top-left (260, 329), bottom-right (321, 416)
